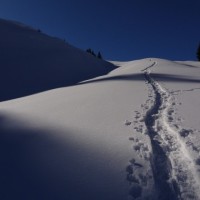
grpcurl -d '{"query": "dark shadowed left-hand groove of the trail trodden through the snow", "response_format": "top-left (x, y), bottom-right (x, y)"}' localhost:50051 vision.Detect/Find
top-left (145, 65), bottom-right (179, 199)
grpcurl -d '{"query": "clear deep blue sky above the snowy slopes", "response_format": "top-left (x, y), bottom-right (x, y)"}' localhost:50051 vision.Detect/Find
top-left (0, 0), bottom-right (200, 60)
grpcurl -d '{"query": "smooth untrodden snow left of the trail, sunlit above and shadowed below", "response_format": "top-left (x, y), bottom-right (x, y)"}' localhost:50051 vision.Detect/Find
top-left (0, 58), bottom-right (148, 200)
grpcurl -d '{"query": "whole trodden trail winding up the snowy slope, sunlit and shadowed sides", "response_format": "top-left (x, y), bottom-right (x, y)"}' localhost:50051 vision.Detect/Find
top-left (143, 62), bottom-right (200, 200)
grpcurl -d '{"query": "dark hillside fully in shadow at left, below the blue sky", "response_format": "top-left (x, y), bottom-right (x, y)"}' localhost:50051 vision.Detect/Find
top-left (0, 19), bottom-right (114, 101)
